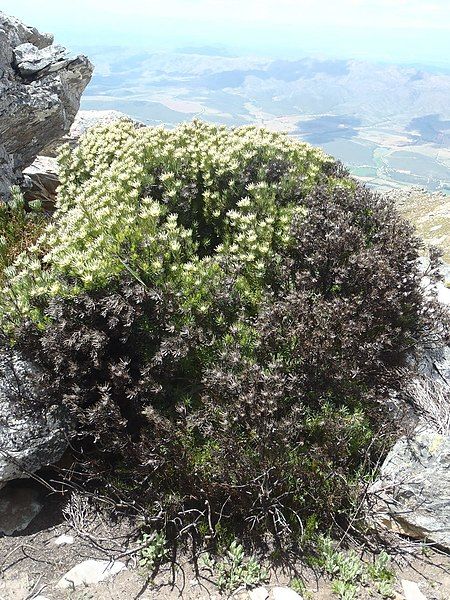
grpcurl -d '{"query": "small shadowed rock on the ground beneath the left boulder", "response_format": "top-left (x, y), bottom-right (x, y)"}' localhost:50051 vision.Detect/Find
top-left (0, 484), bottom-right (44, 535)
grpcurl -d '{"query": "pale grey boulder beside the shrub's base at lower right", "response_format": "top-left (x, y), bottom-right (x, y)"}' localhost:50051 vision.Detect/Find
top-left (371, 425), bottom-right (450, 548)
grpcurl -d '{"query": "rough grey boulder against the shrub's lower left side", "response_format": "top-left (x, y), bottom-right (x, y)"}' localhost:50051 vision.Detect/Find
top-left (0, 351), bottom-right (68, 487)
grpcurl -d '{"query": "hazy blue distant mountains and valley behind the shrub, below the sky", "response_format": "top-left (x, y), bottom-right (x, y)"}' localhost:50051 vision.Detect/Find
top-left (78, 47), bottom-right (450, 193)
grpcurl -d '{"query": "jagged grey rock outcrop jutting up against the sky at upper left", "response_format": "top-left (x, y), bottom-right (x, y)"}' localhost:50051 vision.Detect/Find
top-left (0, 12), bottom-right (93, 199)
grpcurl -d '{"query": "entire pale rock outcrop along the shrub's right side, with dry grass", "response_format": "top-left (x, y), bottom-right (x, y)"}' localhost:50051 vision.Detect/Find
top-left (369, 261), bottom-right (450, 549)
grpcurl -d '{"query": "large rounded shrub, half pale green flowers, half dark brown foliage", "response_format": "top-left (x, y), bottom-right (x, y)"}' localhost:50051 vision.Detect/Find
top-left (4, 122), bottom-right (442, 539)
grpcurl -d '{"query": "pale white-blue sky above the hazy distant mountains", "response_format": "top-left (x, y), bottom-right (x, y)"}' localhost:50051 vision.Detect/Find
top-left (0, 0), bottom-right (450, 67)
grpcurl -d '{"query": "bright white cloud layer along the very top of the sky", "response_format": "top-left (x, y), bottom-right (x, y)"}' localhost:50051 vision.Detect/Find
top-left (2, 0), bottom-right (450, 30)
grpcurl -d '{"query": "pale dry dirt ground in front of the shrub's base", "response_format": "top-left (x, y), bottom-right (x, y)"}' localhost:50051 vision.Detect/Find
top-left (0, 488), bottom-right (450, 600)
